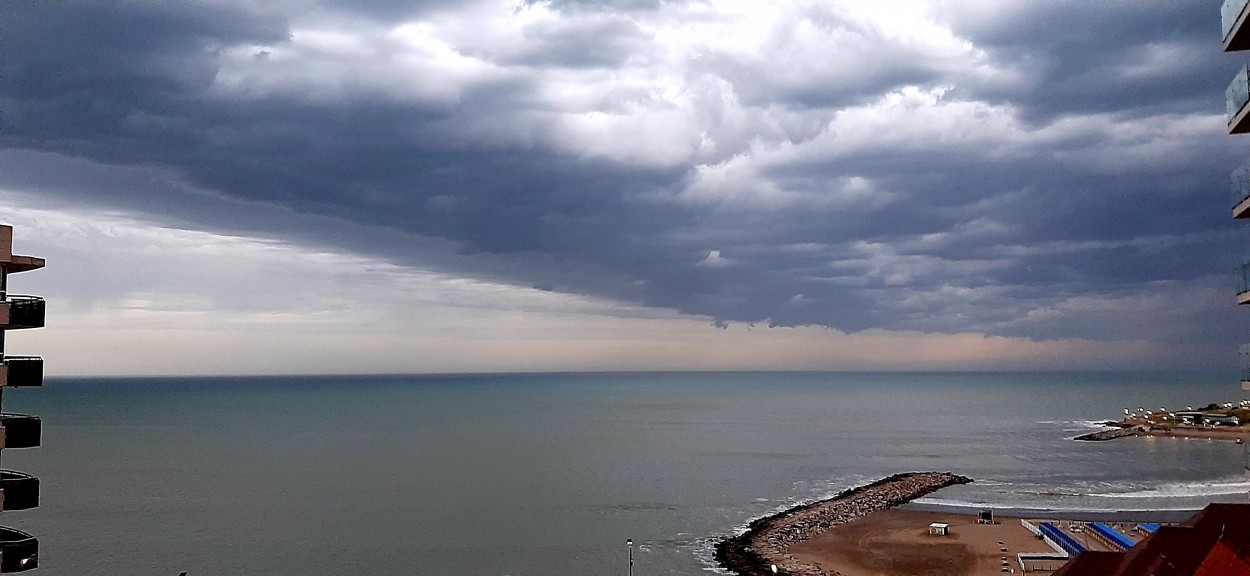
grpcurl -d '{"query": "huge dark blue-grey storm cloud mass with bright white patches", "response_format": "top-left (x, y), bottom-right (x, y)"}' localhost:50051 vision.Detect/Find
top-left (0, 1), bottom-right (1244, 342)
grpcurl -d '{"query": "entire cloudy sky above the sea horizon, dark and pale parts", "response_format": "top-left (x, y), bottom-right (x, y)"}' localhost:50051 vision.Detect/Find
top-left (0, 0), bottom-right (1250, 374)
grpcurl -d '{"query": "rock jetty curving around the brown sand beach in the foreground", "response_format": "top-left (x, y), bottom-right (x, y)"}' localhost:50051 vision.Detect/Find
top-left (716, 472), bottom-right (973, 576)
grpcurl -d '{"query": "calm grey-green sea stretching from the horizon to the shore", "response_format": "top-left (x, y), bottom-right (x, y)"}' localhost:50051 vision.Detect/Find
top-left (0, 374), bottom-right (1250, 576)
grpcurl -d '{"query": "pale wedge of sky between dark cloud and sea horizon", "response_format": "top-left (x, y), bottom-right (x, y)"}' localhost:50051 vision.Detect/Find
top-left (0, 197), bottom-right (1183, 375)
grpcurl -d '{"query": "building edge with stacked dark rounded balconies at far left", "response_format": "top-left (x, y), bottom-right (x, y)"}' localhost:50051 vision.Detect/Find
top-left (0, 225), bottom-right (45, 574)
